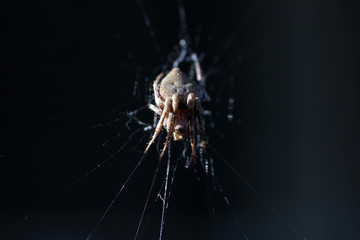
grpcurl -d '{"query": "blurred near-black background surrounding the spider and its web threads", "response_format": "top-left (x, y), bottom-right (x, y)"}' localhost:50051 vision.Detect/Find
top-left (0, 1), bottom-right (360, 239)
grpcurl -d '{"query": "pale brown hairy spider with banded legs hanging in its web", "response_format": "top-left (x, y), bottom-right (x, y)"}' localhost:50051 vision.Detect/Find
top-left (145, 61), bottom-right (210, 163)
